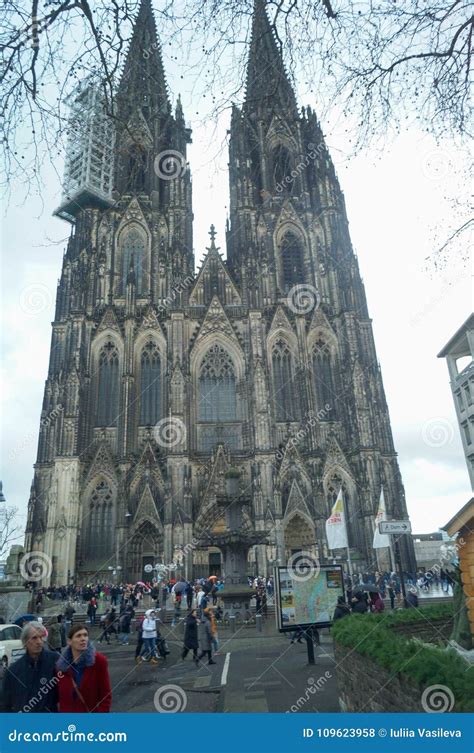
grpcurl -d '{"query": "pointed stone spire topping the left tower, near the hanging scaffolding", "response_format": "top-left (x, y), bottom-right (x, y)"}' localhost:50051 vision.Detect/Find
top-left (118, 0), bottom-right (171, 113)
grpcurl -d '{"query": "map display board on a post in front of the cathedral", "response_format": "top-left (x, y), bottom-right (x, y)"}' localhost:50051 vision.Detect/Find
top-left (275, 565), bottom-right (344, 632)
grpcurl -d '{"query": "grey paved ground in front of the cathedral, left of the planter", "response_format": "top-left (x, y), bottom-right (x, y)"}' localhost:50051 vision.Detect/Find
top-left (98, 619), bottom-right (340, 713)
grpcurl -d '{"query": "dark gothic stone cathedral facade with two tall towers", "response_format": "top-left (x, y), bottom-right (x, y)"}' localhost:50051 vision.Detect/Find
top-left (26, 0), bottom-right (415, 585)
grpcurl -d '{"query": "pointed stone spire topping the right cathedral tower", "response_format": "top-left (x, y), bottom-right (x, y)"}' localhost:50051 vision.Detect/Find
top-left (245, 0), bottom-right (297, 110)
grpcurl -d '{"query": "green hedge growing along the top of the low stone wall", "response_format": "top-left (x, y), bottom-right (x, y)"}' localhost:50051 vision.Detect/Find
top-left (332, 604), bottom-right (474, 712)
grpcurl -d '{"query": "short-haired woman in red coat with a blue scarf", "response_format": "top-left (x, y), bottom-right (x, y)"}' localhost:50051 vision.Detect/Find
top-left (56, 625), bottom-right (112, 713)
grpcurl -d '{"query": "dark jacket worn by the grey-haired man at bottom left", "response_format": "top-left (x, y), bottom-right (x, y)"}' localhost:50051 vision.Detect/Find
top-left (1, 648), bottom-right (58, 713)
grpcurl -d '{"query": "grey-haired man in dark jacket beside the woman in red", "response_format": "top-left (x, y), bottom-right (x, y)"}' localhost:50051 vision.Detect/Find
top-left (1, 622), bottom-right (58, 713)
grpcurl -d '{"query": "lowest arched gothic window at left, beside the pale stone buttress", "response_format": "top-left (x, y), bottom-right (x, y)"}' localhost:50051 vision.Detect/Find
top-left (84, 480), bottom-right (114, 565)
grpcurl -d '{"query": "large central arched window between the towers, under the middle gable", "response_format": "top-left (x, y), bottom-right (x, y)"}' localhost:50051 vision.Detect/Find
top-left (199, 345), bottom-right (237, 421)
